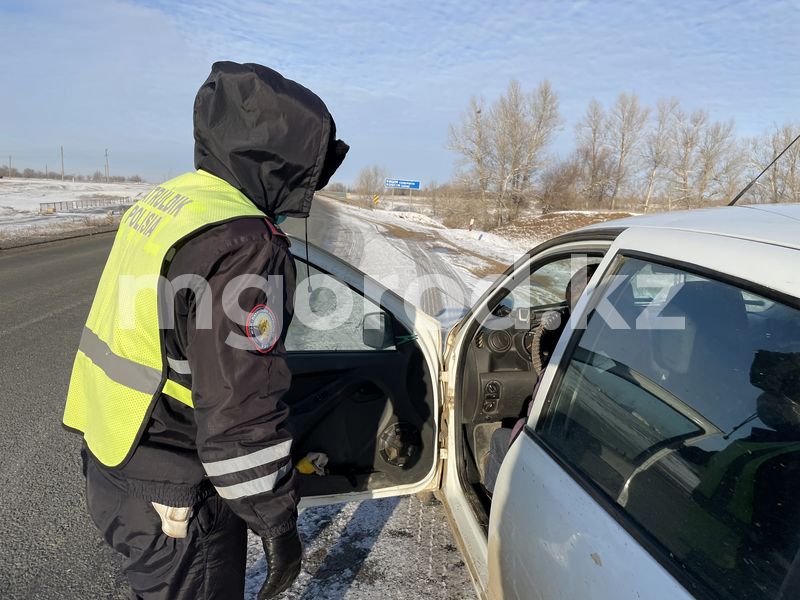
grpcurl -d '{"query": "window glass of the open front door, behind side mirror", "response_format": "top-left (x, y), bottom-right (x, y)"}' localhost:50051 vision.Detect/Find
top-left (285, 265), bottom-right (394, 352)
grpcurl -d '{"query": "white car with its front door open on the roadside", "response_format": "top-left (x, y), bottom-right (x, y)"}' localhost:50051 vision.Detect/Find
top-left (278, 205), bottom-right (800, 600)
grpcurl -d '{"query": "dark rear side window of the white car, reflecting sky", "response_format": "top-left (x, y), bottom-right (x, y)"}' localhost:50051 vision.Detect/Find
top-left (536, 258), bottom-right (800, 599)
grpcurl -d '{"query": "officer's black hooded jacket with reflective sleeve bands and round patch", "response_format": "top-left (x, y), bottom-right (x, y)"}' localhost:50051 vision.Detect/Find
top-left (87, 62), bottom-right (348, 537)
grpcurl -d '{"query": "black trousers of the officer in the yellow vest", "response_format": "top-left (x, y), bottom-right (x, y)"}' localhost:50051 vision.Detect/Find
top-left (86, 460), bottom-right (247, 600)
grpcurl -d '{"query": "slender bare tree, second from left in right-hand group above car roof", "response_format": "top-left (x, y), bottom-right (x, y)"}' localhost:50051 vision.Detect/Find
top-left (607, 92), bottom-right (650, 210)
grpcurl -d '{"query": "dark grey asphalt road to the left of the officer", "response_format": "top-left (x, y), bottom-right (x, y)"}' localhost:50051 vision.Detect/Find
top-left (0, 234), bottom-right (125, 598)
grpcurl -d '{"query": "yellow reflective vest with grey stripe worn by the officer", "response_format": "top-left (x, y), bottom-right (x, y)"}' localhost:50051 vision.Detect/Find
top-left (64, 171), bottom-right (266, 467)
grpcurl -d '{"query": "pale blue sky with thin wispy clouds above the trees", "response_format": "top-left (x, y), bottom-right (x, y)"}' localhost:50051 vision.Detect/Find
top-left (0, 0), bottom-right (800, 185)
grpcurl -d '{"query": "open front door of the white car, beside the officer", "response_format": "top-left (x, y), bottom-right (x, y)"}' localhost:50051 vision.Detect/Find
top-left (284, 238), bottom-right (441, 507)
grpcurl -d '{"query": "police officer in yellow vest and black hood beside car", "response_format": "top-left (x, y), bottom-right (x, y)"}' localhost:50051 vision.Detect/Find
top-left (64, 62), bottom-right (348, 600)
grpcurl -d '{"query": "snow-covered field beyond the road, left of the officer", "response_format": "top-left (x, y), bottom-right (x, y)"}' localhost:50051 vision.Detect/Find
top-left (0, 178), bottom-right (153, 238)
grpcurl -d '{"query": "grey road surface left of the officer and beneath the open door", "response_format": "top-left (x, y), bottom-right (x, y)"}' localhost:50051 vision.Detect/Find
top-left (0, 203), bottom-right (474, 600)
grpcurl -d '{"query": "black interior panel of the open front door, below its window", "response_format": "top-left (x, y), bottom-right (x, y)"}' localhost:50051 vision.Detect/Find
top-left (284, 343), bottom-right (436, 497)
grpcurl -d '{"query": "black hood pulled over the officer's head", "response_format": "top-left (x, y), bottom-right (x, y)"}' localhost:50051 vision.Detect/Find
top-left (194, 62), bottom-right (349, 218)
